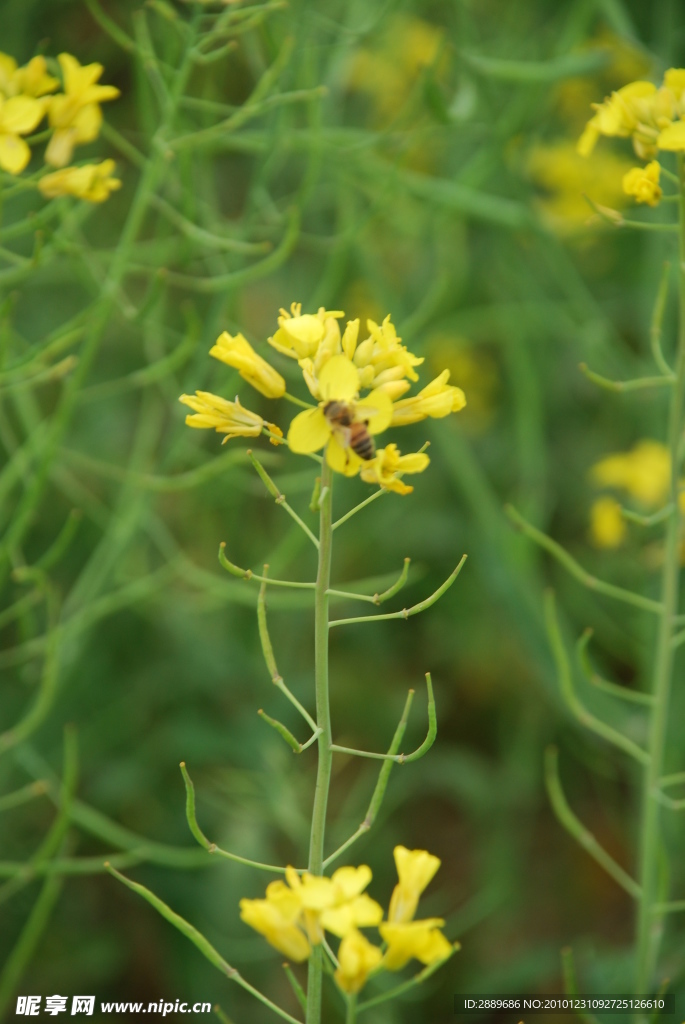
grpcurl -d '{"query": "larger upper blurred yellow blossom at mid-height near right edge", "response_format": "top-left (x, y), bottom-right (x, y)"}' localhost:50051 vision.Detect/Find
top-left (591, 440), bottom-right (671, 508)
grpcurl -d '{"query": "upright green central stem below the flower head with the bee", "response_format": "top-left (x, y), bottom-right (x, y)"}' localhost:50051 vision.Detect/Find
top-left (306, 461), bottom-right (333, 1024)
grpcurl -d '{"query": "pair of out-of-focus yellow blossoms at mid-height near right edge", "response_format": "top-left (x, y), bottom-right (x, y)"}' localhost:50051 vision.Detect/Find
top-left (590, 440), bottom-right (671, 548)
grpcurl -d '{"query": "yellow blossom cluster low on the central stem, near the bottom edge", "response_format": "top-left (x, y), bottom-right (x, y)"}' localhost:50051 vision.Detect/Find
top-left (241, 846), bottom-right (458, 993)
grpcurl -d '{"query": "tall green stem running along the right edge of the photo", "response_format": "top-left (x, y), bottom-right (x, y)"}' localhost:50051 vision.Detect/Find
top-left (636, 154), bottom-right (685, 994)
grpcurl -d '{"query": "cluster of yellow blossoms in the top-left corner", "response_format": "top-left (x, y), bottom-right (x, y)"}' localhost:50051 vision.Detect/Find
top-left (0, 53), bottom-right (121, 203)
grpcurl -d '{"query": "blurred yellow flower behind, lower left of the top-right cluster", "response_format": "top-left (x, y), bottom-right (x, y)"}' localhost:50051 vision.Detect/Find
top-left (528, 140), bottom-right (631, 227)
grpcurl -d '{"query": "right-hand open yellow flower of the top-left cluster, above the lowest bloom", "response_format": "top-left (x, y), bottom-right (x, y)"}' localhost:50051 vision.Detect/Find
top-left (45, 53), bottom-right (120, 167)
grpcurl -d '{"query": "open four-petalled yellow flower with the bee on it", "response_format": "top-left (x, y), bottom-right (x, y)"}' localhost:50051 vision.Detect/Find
top-left (288, 355), bottom-right (392, 476)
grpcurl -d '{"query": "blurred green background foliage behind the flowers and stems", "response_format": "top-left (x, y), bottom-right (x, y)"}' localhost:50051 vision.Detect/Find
top-left (0, 0), bottom-right (685, 1024)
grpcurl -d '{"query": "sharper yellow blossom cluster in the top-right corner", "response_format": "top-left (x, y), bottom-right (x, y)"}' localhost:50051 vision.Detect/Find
top-left (577, 68), bottom-right (685, 206)
